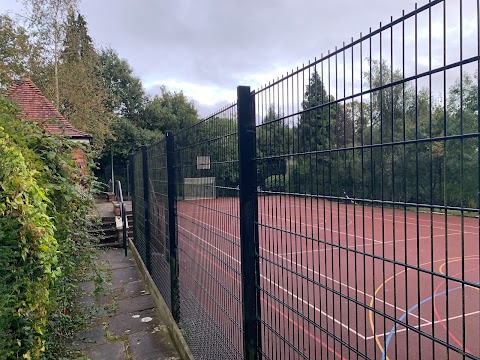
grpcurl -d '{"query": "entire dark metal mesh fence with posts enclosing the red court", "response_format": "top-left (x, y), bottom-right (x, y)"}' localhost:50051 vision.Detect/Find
top-left (133, 0), bottom-right (480, 360)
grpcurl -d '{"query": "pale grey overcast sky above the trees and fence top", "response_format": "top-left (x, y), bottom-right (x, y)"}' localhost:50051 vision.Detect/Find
top-left (0, 0), bottom-right (478, 116)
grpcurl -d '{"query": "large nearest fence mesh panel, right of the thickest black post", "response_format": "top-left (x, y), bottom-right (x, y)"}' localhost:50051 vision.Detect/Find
top-left (255, 1), bottom-right (480, 359)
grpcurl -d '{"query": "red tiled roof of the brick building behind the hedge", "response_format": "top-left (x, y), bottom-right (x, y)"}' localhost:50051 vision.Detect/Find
top-left (6, 77), bottom-right (91, 139)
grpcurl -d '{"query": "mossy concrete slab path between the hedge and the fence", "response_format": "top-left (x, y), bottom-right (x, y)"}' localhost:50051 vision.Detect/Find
top-left (69, 249), bottom-right (180, 360)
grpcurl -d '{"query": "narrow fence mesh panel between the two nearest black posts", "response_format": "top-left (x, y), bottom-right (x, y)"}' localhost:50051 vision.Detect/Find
top-left (175, 105), bottom-right (243, 359)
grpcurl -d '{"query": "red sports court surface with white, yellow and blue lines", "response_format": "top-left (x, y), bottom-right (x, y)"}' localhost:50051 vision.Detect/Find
top-left (177, 196), bottom-right (480, 359)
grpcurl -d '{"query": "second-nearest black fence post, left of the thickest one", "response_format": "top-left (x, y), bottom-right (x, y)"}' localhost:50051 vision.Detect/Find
top-left (165, 131), bottom-right (180, 322)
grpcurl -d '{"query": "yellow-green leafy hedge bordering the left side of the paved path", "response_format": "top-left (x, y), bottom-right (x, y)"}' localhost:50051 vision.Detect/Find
top-left (0, 97), bottom-right (97, 359)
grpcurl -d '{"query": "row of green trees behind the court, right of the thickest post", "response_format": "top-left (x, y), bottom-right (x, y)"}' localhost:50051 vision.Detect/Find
top-left (286, 60), bottom-right (479, 208)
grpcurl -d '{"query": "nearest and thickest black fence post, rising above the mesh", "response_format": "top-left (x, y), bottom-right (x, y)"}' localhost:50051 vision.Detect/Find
top-left (237, 86), bottom-right (261, 360)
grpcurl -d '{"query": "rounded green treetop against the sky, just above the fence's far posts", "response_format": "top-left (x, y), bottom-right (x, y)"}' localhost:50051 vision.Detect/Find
top-left (140, 86), bottom-right (198, 133)
